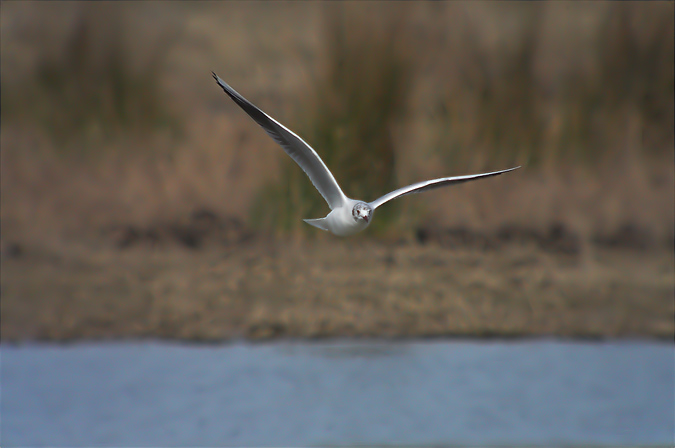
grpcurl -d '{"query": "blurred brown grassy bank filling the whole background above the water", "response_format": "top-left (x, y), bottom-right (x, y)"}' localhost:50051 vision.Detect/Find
top-left (0, 2), bottom-right (675, 339)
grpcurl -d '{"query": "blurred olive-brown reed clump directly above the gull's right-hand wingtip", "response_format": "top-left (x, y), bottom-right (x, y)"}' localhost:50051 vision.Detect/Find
top-left (438, 4), bottom-right (544, 167)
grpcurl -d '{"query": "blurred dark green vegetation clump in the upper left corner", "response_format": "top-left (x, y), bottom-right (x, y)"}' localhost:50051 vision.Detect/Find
top-left (2, 2), bottom-right (180, 149)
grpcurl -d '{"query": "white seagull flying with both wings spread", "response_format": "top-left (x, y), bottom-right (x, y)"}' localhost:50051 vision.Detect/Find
top-left (211, 72), bottom-right (520, 236)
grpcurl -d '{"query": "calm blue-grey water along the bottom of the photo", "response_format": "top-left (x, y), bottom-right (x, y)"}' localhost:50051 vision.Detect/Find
top-left (0, 341), bottom-right (675, 447)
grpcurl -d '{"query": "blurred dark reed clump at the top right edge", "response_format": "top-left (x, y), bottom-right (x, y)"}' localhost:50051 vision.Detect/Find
top-left (588, 2), bottom-right (675, 150)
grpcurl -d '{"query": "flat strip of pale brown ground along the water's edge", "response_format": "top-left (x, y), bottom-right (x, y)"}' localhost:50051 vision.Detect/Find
top-left (1, 238), bottom-right (675, 341)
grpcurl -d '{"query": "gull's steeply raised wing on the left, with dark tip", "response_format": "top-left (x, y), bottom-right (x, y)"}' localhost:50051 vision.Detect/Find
top-left (211, 72), bottom-right (347, 210)
